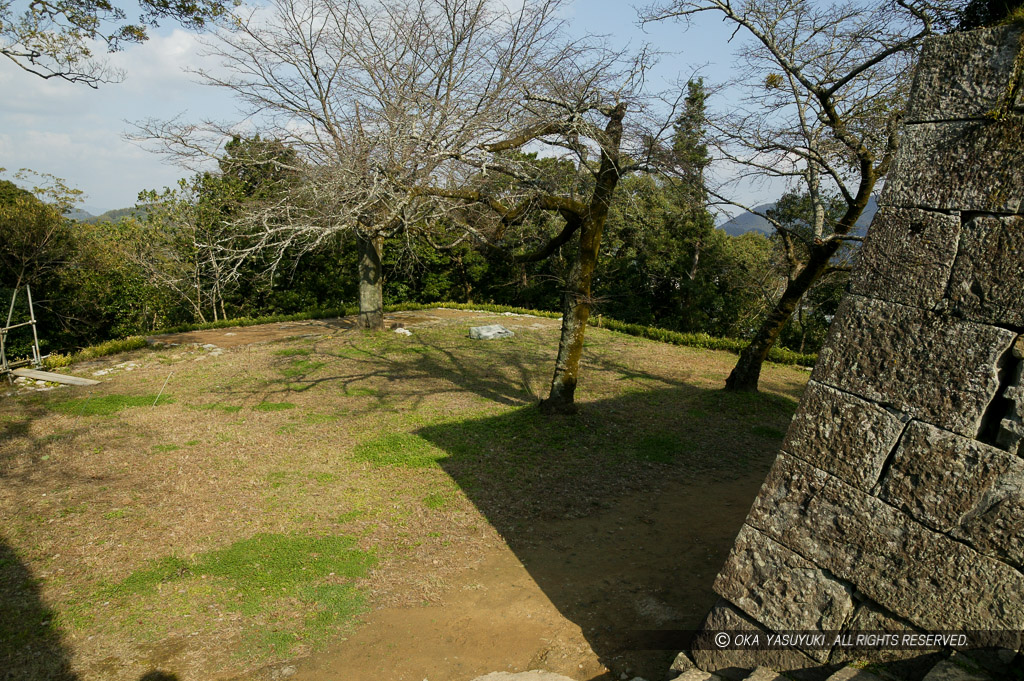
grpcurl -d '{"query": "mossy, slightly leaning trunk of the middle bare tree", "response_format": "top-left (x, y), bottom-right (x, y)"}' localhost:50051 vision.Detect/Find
top-left (541, 104), bottom-right (626, 414)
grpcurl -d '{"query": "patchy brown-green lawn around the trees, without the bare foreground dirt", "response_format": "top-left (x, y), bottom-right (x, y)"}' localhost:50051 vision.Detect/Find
top-left (0, 309), bottom-right (807, 681)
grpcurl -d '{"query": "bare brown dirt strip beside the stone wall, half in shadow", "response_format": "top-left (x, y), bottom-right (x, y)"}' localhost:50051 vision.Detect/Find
top-left (250, 471), bottom-right (763, 681)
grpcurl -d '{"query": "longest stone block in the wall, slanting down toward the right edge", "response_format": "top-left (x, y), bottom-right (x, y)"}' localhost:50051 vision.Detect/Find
top-left (746, 453), bottom-right (1024, 630)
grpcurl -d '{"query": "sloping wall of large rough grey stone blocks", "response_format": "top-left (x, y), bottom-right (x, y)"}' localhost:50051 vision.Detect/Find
top-left (693, 25), bottom-right (1024, 671)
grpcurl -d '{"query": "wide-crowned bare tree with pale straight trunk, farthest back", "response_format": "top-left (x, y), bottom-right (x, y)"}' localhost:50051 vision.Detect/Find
top-left (141, 0), bottom-right (560, 329)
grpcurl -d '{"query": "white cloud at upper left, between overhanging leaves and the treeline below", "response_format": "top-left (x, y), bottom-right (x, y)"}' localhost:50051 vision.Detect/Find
top-left (0, 30), bottom-right (233, 210)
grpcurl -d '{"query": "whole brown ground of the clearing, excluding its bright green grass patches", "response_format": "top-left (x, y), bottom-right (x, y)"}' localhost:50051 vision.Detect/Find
top-left (0, 309), bottom-right (806, 681)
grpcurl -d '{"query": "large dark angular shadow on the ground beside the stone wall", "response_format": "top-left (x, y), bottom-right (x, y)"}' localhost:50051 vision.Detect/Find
top-left (417, 385), bottom-right (796, 681)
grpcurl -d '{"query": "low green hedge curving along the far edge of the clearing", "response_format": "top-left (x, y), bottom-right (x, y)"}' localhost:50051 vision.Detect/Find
top-left (45, 302), bottom-right (818, 368)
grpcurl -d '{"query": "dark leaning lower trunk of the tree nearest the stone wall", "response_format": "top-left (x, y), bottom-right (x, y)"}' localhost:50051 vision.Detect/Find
top-left (725, 242), bottom-right (839, 392)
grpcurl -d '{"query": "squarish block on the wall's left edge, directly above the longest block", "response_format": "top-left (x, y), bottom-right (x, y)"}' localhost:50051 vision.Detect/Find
top-left (782, 381), bottom-right (904, 492)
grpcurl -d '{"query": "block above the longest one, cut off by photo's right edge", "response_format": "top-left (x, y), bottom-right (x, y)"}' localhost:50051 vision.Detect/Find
top-left (880, 421), bottom-right (1024, 565)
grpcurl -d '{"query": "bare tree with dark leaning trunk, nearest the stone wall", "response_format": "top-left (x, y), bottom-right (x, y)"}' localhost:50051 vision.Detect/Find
top-left (643, 0), bottom-right (954, 390)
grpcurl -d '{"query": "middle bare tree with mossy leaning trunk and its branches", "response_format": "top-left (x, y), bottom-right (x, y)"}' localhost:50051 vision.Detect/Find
top-left (423, 45), bottom-right (682, 413)
